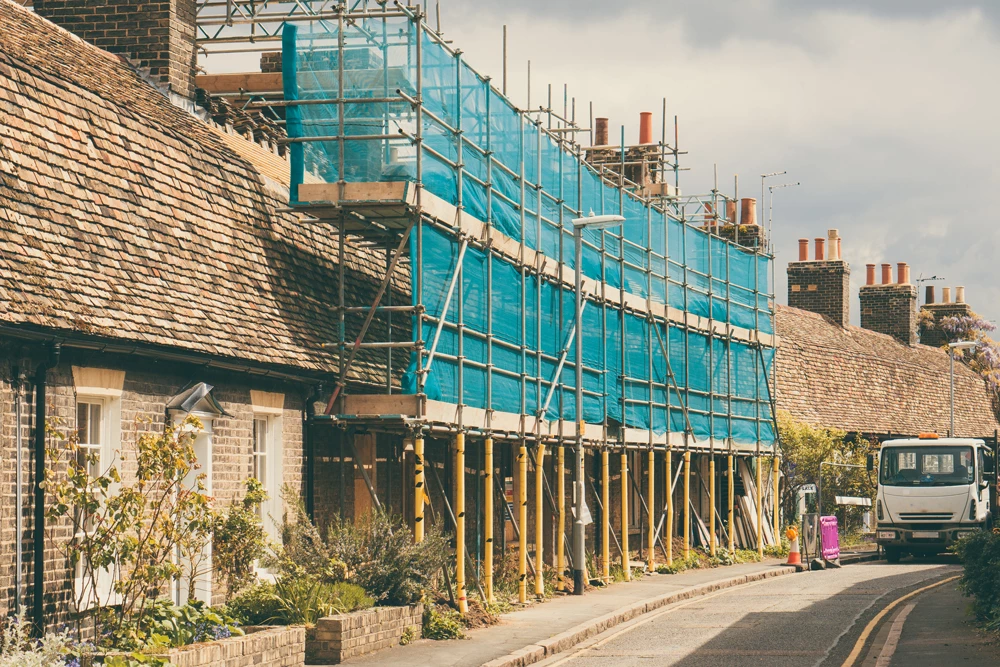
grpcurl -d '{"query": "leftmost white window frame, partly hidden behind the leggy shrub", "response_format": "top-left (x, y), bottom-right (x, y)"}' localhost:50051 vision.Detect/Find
top-left (73, 386), bottom-right (124, 611)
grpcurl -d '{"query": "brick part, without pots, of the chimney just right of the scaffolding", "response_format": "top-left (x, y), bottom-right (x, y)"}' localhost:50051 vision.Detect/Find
top-left (788, 260), bottom-right (851, 327)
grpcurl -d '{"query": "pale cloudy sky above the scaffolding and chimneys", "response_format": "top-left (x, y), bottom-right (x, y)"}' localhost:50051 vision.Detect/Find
top-left (203, 0), bottom-right (1000, 323)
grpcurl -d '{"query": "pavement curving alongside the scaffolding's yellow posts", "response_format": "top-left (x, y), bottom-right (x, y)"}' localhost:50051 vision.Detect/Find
top-left (347, 559), bottom-right (802, 667)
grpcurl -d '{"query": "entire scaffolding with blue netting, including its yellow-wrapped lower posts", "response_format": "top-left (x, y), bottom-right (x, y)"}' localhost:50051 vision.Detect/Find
top-left (198, 0), bottom-right (778, 596)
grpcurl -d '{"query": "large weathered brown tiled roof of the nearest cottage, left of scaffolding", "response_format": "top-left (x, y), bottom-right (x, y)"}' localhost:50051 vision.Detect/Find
top-left (0, 0), bottom-right (405, 381)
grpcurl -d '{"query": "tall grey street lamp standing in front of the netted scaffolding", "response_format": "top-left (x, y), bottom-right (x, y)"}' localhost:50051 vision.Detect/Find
top-left (576, 214), bottom-right (625, 595)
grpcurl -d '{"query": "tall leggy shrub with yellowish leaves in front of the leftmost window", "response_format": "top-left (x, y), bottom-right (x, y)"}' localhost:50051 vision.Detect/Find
top-left (44, 417), bottom-right (214, 637)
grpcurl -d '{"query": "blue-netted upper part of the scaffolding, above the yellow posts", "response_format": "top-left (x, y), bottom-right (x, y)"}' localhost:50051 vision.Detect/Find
top-left (283, 5), bottom-right (774, 450)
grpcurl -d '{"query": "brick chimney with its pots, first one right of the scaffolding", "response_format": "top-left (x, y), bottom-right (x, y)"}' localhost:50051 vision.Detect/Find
top-left (788, 228), bottom-right (851, 327)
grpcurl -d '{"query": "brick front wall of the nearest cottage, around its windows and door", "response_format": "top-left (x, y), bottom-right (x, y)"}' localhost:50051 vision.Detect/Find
top-left (0, 348), bottom-right (308, 627)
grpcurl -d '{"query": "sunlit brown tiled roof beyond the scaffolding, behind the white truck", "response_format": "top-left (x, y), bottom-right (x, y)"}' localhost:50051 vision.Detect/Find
top-left (776, 306), bottom-right (998, 436)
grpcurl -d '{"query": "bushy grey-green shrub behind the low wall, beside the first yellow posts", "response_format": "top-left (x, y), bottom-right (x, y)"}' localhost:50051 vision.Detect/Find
top-left (326, 510), bottom-right (449, 605)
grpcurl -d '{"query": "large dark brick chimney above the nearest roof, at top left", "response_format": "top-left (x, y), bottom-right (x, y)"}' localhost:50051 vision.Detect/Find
top-left (34, 0), bottom-right (196, 97)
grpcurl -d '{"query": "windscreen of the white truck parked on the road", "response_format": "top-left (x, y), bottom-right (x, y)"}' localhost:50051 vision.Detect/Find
top-left (879, 447), bottom-right (975, 486)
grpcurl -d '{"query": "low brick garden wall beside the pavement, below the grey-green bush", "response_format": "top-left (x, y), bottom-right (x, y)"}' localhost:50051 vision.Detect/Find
top-left (306, 604), bottom-right (424, 665)
